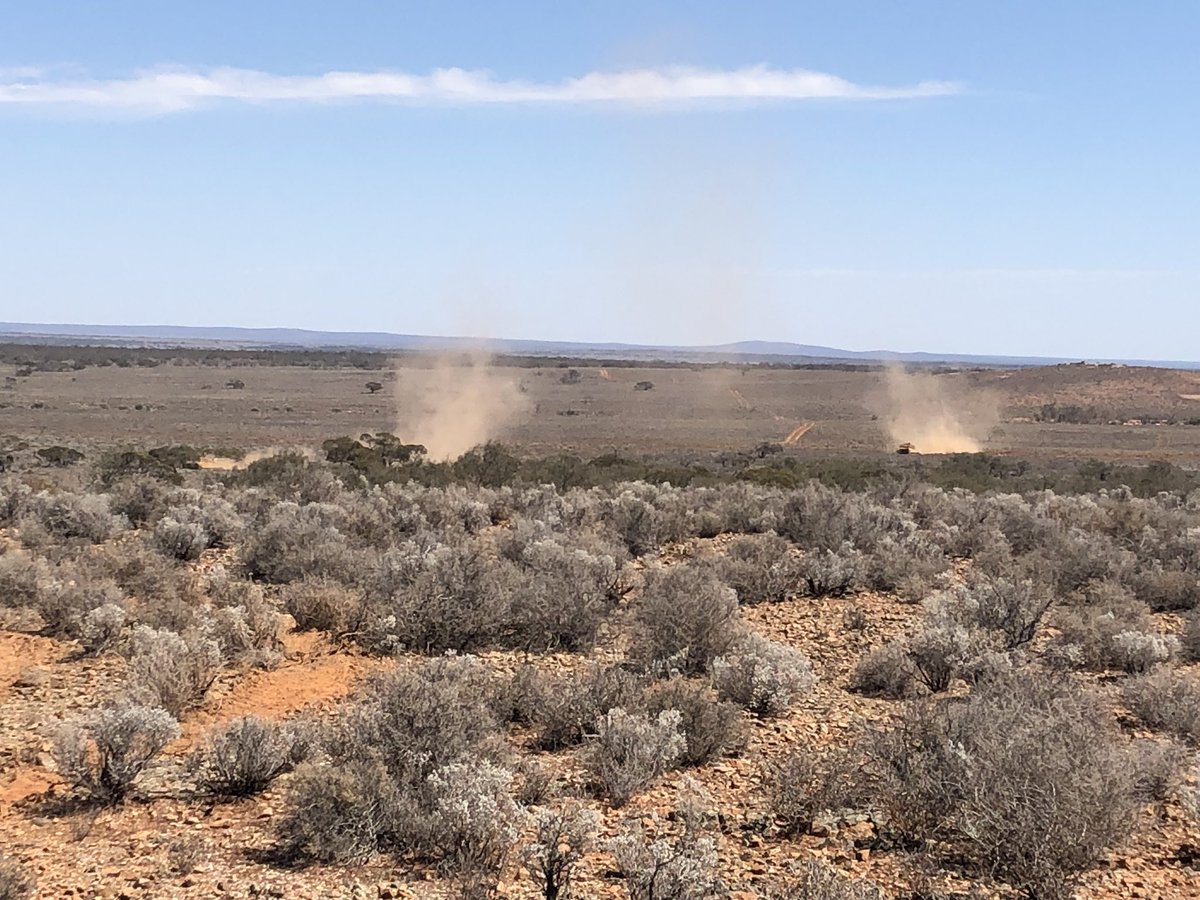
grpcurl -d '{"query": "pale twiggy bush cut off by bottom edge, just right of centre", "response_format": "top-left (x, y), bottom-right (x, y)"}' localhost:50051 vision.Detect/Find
top-left (608, 821), bottom-right (725, 900)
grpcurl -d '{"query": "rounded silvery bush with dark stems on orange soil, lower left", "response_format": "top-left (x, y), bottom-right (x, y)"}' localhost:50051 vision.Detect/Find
top-left (52, 702), bottom-right (179, 803)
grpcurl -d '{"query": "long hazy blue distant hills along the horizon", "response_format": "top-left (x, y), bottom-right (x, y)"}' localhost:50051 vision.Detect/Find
top-left (0, 322), bottom-right (1200, 368)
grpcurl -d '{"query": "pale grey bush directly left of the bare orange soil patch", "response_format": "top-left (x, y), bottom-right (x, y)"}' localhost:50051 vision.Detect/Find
top-left (128, 625), bottom-right (221, 716)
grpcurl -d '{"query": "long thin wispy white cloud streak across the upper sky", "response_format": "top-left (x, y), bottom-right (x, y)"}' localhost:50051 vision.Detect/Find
top-left (0, 66), bottom-right (961, 114)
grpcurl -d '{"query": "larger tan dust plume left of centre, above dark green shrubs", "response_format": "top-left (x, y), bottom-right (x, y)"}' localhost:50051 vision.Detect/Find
top-left (395, 350), bottom-right (528, 462)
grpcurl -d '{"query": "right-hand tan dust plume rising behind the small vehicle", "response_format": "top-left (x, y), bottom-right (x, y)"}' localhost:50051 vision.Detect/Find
top-left (872, 366), bottom-right (1000, 454)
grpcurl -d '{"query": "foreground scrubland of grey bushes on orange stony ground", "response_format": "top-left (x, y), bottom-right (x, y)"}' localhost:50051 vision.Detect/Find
top-left (0, 434), bottom-right (1200, 900)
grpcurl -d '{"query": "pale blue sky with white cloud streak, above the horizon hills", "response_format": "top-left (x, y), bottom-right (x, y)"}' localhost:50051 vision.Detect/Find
top-left (0, 0), bottom-right (1200, 359)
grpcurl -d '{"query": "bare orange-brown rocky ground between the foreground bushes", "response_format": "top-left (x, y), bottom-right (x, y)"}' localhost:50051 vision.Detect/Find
top-left (0, 540), bottom-right (1200, 900)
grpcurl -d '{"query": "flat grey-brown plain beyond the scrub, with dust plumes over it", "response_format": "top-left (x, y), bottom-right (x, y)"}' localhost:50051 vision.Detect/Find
top-left (7, 365), bottom-right (1200, 464)
